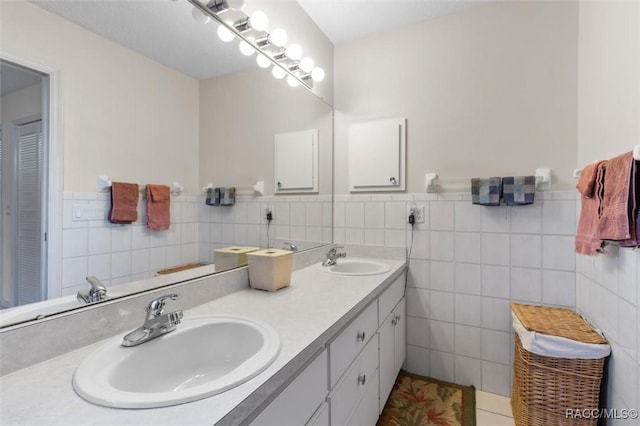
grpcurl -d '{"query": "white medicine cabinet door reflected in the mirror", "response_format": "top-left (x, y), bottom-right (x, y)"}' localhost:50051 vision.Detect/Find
top-left (274, 130), bottom-right (319, 193)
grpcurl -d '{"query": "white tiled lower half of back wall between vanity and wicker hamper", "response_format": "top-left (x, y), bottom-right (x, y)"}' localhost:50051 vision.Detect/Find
top-left (334, 191), bottom-right (580, 396)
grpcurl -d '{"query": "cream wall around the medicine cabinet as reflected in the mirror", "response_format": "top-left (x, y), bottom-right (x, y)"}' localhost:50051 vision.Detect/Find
top-left (199, 69), bottom-right (332, 195)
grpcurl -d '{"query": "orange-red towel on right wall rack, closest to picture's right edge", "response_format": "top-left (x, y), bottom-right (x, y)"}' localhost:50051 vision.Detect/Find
top-left (598, 151), bottom-right (635, 241)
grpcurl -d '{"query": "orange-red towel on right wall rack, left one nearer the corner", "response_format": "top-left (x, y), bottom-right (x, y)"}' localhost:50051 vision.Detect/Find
top-left (576, 161), bottom-right (607, 255)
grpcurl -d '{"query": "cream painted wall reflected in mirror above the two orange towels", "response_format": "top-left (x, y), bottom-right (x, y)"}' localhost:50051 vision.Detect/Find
top-left (0, 0), bottom-right (198, 192)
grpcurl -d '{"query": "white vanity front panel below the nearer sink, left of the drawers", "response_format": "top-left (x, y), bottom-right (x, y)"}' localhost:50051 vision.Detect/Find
top-left (250, 351), bottom-right (327, 426)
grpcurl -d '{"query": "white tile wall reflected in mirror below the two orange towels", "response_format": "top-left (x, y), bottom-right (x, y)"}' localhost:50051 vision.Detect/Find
top-left (62, 193), bottom-right (198, 295)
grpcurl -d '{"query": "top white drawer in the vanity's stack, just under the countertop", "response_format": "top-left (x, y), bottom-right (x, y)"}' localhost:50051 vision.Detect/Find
top-left (329, 302), bottom-right (378, 388)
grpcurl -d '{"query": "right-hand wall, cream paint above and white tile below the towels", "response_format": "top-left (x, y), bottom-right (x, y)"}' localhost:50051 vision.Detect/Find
top-left (576, 2), bottom-right (640, 425)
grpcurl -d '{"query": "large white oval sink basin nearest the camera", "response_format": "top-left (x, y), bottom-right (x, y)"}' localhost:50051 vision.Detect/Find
top-left (73, 315), bottom-right (280, 408)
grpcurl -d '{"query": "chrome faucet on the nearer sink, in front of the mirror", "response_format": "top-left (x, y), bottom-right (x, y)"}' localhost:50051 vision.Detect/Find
top-left (122, 293), bottom-right (183, 346)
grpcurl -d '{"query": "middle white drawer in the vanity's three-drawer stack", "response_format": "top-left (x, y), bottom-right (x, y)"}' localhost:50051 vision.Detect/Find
top-left (329, 334), bottom-right (378, 425)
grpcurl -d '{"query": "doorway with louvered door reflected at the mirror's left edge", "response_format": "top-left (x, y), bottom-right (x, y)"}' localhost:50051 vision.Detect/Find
top-left (0, 60), bottom-right (49, 308)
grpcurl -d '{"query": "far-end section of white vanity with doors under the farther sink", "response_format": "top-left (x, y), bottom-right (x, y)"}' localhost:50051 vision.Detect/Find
top-left (378, 274), bottom-right (406, 413)
